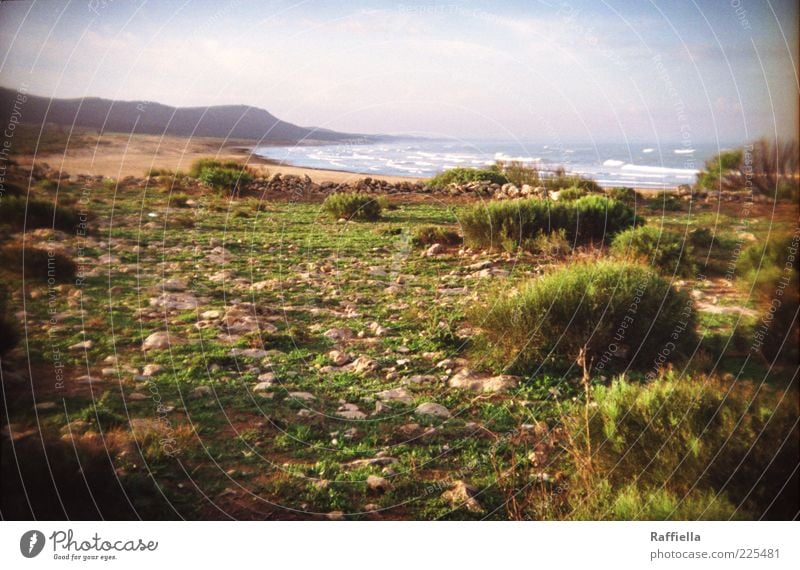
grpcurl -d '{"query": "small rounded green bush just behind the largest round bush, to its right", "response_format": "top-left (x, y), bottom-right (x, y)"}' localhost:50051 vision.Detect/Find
top-left (611, 226), bottom-right (695, 276)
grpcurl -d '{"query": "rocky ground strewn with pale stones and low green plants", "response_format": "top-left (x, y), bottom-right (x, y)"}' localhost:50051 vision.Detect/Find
top-left (3, 166), bottom-right (792, 519)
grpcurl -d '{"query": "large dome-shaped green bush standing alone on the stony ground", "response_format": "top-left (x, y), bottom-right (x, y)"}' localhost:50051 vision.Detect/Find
top-left (471, 261), bottom-right (697, 373)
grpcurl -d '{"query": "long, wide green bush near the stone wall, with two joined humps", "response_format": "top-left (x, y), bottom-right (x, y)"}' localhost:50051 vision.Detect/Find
top-left (459, 196), bottom-right (637, 249)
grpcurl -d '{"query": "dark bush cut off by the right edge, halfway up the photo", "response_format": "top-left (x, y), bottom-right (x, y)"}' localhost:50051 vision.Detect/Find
top-left (736, 234), bottom-right (800, 365)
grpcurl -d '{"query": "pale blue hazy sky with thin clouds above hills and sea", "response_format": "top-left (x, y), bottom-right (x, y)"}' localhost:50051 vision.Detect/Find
top-left (0, 0), bottom-right (799, 143)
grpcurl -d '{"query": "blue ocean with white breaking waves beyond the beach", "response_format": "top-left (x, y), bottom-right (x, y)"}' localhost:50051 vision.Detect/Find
top-left (253, 140), bottom-right (730, 190)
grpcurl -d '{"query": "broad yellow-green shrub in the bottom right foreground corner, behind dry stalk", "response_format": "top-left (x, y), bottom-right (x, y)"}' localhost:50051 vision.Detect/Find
top-left (566, 376), bottom-right (800, 518)
